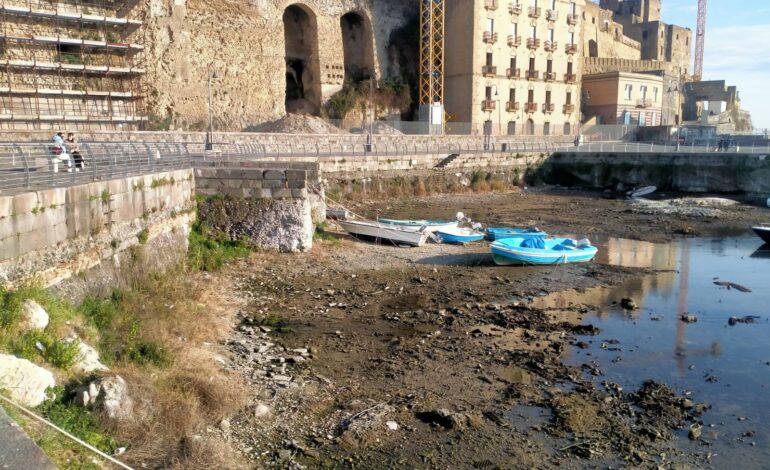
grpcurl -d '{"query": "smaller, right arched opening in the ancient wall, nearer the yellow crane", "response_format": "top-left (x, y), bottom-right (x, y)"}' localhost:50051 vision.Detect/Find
top-left (340, 12), bottom-right (374, 82)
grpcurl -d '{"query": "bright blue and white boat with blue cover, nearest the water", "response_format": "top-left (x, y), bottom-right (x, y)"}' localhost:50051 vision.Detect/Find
top-left (490, 238), bottom-right (599, 266)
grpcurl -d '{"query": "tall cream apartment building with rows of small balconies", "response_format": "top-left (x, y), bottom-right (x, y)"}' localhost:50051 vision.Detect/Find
top-left (445, 0), bottom-right (585, 135)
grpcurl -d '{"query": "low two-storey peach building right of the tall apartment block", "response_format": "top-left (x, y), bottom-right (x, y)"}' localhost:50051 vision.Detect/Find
top-left (583, 72), bottom-right (664, 126)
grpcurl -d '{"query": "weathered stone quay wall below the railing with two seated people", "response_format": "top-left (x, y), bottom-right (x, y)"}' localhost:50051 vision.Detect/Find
top-left (0, 170), bottom-right (194, 285)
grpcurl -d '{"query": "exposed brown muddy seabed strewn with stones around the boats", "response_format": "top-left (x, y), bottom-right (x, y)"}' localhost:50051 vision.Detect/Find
top-left (222, 192), bottom-right (761, 469)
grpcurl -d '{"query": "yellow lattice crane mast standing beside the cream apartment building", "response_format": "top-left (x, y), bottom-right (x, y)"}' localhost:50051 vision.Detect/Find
top-left (420, 0), bottom-right (445, 133)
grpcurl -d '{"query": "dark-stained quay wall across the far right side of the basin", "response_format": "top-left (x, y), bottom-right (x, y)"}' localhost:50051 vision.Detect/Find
top-left (542, 153), bottom-right (770, 194)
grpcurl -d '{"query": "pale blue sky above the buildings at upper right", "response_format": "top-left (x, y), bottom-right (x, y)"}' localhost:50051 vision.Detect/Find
top-left (661, 0), bottom-right (770, 129)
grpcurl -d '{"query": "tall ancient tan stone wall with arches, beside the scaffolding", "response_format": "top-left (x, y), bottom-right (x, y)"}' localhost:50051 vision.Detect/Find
top-left (146, 0), bottom-right (419, 131)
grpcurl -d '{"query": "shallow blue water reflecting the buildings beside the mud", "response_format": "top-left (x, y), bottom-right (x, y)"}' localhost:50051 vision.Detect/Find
top-left (533, 236), bottom-right (770, 468)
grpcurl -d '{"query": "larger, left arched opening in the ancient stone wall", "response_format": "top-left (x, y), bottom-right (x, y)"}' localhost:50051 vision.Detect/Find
top-left (283, 4), bottom-right (321, 114)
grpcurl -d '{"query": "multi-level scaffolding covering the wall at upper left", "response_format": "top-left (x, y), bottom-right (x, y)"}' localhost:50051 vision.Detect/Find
top-left (0, 0), bottom-right (148, 130)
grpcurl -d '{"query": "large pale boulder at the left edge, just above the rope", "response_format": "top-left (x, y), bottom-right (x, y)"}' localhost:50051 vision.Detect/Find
top-left (0, 354), bottom-right (56, 407)
